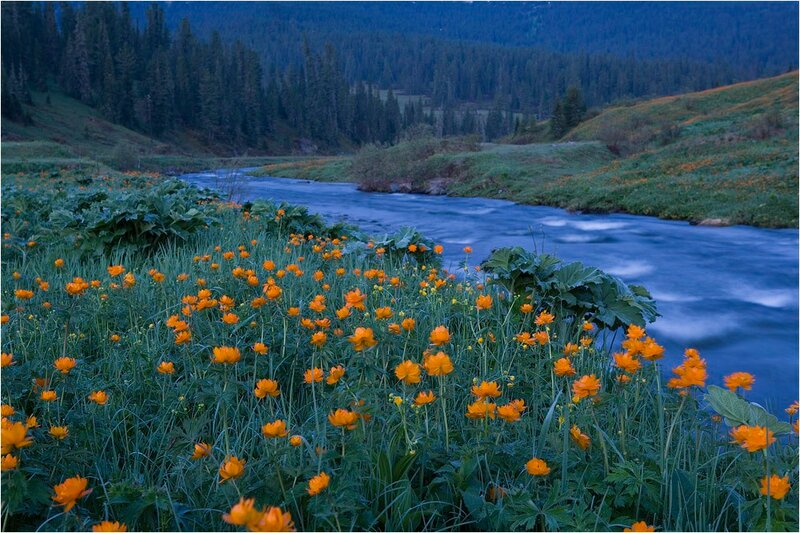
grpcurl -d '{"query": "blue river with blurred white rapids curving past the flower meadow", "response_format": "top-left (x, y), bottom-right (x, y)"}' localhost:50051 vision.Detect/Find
top-left (181, 169), bottom-right (798, 408)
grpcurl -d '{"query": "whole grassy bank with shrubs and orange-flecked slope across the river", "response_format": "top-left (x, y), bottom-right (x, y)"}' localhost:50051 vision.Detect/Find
top-left (253, 72), bottom-right (798, 227)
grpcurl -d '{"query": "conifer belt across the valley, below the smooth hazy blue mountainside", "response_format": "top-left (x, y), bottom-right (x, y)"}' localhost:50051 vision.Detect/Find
top-left (2, 2), bottom-right (752, 150)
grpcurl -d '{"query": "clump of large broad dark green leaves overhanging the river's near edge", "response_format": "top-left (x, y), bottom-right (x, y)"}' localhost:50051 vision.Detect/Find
top-left (482, 246), bottom-right (659, 330)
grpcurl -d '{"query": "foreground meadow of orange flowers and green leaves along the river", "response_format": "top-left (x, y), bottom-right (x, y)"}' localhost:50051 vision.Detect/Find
top-left (2, 169), bottom-right (799, 531)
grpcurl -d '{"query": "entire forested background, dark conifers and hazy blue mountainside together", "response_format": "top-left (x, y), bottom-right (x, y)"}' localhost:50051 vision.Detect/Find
top-left (2, 2), bottom-right (796, 153)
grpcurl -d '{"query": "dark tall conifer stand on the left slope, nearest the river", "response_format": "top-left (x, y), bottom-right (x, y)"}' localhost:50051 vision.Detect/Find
top-left (2, 2), bottom-right (446, 149)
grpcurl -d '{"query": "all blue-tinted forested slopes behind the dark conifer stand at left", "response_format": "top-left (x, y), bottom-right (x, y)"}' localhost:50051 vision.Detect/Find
top-left (153, 2), bottom-right (797, 109)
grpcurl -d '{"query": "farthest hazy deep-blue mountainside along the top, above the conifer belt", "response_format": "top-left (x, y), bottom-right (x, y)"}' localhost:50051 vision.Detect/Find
top-left (158, 2), bottom-right (798, 70)
